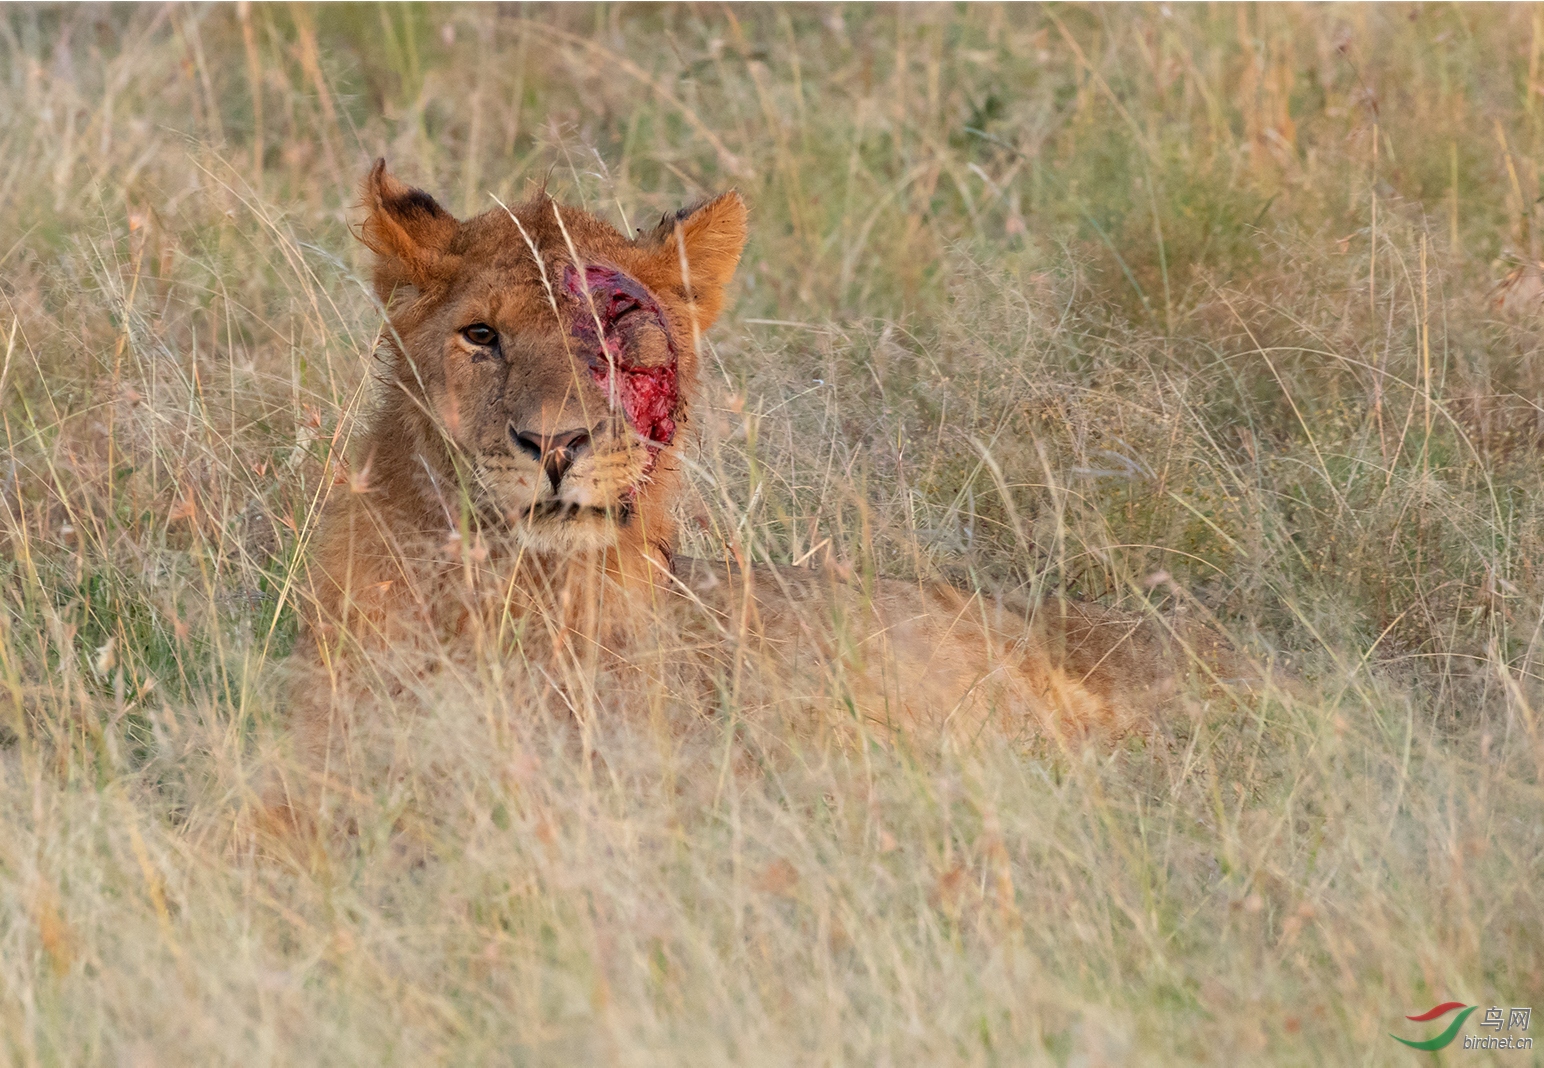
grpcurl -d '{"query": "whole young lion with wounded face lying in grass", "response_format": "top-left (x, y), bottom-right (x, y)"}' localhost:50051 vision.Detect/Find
top-left (284, 161), bottom-right (1235, 802)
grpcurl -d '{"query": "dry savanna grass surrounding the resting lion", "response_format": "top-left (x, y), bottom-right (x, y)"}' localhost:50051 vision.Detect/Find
top-left (0, 3), bottom-right (1544, 1065)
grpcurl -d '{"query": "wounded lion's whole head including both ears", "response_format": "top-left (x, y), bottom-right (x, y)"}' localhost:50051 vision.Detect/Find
top-left (364, 164), bottom-right (746, 551)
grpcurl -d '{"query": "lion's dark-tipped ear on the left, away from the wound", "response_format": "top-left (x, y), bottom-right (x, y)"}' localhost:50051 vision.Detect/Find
top-left (360, 159), bottom-right (460, 302)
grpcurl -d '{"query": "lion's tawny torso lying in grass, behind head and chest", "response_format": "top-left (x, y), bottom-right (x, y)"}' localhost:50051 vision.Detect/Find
top-left (676, 560), bottom-right (1220, 738)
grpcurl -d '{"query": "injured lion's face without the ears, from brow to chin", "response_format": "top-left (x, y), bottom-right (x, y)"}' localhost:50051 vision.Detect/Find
top-left (400, 257), bottom-right (682, 543)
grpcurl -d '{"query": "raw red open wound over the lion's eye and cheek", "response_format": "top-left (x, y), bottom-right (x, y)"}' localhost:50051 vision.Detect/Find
top-left (564, 267), bottom-right (681, 453)
